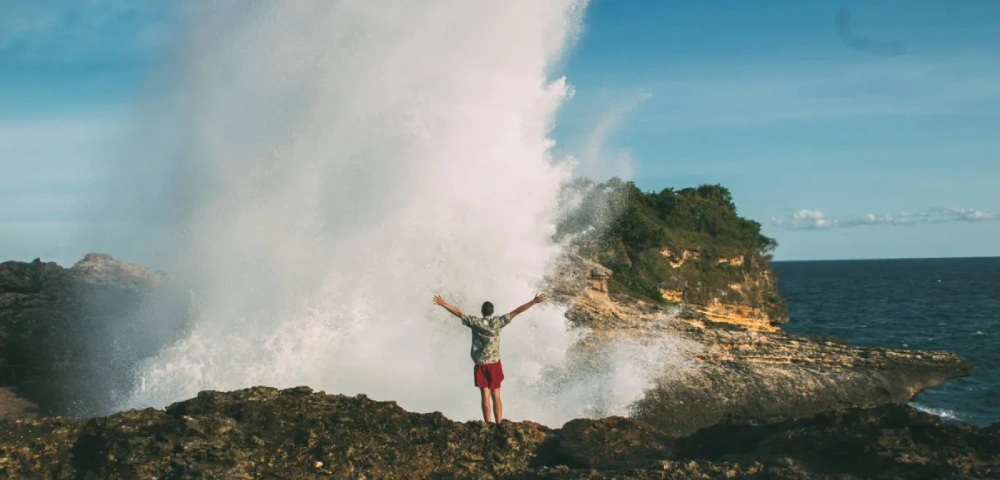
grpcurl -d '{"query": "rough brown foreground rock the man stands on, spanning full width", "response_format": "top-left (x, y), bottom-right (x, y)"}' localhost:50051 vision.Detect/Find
top-left (0, 387), bottom-right (1000, 479)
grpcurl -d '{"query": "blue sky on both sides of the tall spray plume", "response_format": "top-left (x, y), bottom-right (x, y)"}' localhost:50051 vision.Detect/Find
top-left (0, 0), bottom-right (1000, 263)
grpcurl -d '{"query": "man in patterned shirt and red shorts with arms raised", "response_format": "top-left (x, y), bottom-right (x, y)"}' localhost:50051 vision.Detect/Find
top-left (434, 294), bottom-right (545, 423)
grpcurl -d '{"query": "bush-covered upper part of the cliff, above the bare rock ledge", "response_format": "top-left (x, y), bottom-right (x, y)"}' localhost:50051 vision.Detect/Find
top-left (557, 178), bottom-right (785, 321)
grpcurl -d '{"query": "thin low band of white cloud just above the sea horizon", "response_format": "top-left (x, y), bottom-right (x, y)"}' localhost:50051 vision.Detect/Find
top-left (771, 207), bottom-right (1000, 230)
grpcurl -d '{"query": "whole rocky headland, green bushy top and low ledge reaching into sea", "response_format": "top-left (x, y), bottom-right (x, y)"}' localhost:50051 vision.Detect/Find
top-left (547, 179), bottom-right (972, 435)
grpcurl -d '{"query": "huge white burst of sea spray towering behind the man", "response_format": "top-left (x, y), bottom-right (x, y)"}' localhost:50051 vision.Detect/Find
top-left (121, 0), bottom-right (692, 425)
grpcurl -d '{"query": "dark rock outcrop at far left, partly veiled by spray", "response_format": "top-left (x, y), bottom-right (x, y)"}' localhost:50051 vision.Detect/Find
top-left (0, 254), bottom-right (187, 415)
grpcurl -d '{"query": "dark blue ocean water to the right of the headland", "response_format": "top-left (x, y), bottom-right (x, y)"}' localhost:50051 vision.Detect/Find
top-left (772, 258), bottom-right (1000, 426)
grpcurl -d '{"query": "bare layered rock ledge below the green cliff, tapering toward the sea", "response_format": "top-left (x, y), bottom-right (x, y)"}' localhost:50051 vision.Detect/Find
top-left (549, 255), bottom-right (972, 435)
